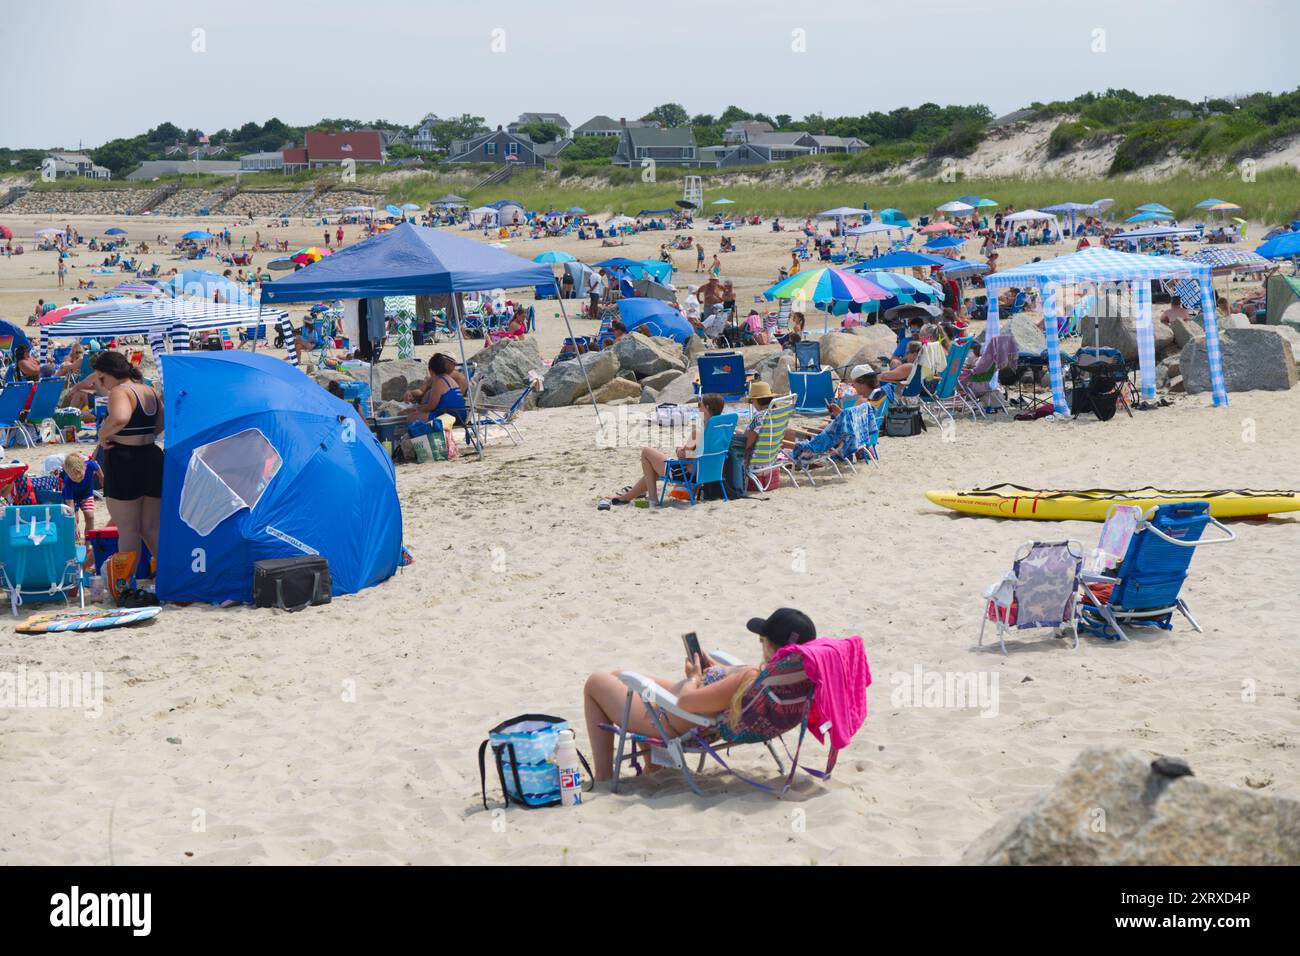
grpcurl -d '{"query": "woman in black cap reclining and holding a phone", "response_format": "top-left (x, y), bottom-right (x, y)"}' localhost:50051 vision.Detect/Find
top-left (582, 607), bottom-right (816, 782)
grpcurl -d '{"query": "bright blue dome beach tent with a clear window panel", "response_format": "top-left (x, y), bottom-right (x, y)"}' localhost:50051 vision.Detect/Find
top-left (157, 351), bottom-right (402, 604)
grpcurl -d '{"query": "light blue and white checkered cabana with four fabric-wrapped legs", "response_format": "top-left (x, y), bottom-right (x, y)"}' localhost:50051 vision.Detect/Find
top-left (984, 248), bottom-right (1229, 414)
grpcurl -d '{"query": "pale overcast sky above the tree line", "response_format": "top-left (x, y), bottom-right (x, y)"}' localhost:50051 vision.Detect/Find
top-left (0, 0), bottom-right (1300, 147)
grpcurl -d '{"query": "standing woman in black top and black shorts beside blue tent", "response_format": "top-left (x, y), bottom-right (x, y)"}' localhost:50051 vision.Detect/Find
top-left (94, 351), bottom-right (163, 604)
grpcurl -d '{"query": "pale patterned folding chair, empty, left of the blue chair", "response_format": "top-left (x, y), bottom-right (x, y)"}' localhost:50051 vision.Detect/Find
top-left (979, 541), bottom-right (1083, 654)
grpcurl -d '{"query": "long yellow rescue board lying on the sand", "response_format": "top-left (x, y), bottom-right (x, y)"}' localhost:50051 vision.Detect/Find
top-left (926, 485), bottom-right (1300, 522)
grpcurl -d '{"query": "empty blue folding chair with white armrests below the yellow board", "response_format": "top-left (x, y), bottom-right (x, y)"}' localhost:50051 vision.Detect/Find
top-left (1078, 501), bottom-right (1236, 640)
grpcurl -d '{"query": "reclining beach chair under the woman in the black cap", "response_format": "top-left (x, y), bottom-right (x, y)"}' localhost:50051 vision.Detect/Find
top-left (601, 650), bottom-right (836, 796)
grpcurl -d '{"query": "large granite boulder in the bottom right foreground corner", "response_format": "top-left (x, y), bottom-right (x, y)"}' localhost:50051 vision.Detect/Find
top-left (962, 748), bottom-right (1300, 866)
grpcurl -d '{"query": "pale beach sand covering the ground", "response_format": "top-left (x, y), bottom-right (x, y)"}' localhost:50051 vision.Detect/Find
top-left (0, 210), bottom-right (1300, 865)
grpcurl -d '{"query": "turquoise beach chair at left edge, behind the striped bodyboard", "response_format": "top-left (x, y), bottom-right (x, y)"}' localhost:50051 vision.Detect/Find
top-left (0, 505), bottom-right (86, 617)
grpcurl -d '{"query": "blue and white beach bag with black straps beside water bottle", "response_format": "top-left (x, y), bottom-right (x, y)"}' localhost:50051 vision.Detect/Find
top-left (478, 714), bottom-right (595, 810)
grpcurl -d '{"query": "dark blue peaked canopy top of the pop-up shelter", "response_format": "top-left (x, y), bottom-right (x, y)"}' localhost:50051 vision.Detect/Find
top-left (261, 222), bottom-right (555, 302)
